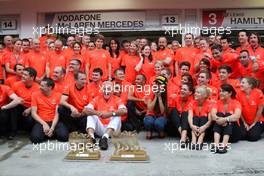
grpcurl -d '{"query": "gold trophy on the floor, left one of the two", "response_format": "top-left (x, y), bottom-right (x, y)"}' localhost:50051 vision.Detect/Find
top-left (65, 132), bottom-right (101, 160)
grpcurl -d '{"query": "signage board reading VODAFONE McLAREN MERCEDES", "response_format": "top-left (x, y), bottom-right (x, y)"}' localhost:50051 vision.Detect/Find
top-left (46, 11), bottom-right (145, 31)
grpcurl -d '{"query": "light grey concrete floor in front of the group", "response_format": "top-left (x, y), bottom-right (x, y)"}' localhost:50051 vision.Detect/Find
top-left (0, 133), bottom-right (264, 176)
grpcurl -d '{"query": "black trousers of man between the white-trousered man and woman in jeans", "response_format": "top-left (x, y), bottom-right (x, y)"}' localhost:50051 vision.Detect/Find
top-left (121, 101), bottom-right (145, 132)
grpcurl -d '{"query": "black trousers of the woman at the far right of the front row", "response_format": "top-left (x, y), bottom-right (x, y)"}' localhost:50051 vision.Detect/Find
top-left (241, 122), bottom-right (264, 142)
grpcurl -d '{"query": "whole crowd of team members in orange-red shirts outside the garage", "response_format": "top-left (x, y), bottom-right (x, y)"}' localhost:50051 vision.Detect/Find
top-left (0, 30), bottom-right (264, 153)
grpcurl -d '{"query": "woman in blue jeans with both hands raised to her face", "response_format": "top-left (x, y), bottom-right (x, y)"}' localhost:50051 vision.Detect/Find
top-left (144, 76), bottom-right (168, 139)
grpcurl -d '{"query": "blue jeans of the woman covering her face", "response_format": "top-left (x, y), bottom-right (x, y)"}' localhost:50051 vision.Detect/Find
top-left (144, 115), bottom-right (167, 132)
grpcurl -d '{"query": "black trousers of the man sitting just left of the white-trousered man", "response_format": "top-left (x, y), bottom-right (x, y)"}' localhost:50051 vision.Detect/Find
top-left (58, 106), bottom-right (87, 133)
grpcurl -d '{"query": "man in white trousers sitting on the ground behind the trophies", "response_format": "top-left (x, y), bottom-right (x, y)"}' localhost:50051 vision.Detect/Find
top-left (84, 81), bottom-right (127, 150)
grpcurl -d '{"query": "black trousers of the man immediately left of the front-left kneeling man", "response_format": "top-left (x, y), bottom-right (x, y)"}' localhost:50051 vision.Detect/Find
top-left (9, 105), bottom-right (35, 135)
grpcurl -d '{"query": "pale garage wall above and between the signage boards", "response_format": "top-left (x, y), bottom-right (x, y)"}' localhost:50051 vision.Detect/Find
top-left (0, 0), bottom-right (264, 37)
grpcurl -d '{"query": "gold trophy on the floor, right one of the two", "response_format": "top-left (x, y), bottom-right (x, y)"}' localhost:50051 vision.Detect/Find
top-left (110, 131), bottom-right (149, 161)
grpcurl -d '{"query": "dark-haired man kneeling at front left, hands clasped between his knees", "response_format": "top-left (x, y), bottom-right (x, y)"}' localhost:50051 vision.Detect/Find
top-left (30, 78), bottom-right (69, 143)
